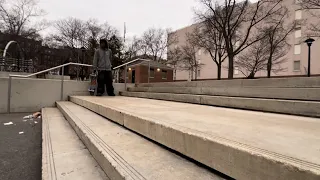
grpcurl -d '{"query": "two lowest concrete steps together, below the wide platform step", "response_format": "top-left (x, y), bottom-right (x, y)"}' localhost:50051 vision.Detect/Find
top-left (42, 102), bottom-right (230, 180)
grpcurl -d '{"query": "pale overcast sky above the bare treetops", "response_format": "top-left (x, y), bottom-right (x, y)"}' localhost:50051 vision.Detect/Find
top-left (39, 0), bottom-right (197, 37)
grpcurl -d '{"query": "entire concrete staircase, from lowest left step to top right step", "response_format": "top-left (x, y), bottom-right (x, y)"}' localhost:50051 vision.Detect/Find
top-left (42, 78), bottom-right (320, 180)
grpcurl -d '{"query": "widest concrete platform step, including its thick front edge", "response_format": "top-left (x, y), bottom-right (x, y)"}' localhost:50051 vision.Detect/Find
top-left (70, 96), bottom-right (320, 180)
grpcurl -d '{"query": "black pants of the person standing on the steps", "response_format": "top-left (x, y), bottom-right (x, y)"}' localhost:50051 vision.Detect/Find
top-left (97, 71), bottom-right (114, 96)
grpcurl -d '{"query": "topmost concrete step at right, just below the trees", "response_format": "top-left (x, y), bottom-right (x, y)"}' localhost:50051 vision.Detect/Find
top-left (137, 77), bottom-right (320, 88)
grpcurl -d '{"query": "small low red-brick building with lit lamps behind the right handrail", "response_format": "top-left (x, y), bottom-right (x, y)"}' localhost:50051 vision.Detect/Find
top-left (127, 61), bottom-right (173, 84)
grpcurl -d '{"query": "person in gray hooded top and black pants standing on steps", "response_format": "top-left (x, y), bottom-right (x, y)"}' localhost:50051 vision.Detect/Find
top-left (93, 39), bottom-right (115, 96)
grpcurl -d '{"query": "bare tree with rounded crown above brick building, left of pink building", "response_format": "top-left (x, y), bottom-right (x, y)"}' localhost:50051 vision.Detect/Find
top-left (141, 28), bottom-right (177, 61)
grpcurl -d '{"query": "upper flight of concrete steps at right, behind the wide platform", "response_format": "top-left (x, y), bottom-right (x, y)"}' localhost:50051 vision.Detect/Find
top-left (121, 77), bottom-right (320, 117)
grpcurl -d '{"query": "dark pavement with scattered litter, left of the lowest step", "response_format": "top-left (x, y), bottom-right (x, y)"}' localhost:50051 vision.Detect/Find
top-left (0, 113), bottom-right (42, 180)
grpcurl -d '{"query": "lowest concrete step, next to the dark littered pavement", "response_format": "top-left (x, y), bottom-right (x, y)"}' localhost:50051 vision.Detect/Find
top-left (42, 108), bottom-right (109, 180)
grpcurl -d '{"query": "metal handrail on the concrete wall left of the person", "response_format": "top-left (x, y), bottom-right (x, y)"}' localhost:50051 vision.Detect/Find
top-left (7, 62), bottom-right (92, 113)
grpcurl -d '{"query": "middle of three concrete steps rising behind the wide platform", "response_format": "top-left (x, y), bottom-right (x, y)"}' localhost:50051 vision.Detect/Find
top-left (128, 87), bottom-right (320, 101)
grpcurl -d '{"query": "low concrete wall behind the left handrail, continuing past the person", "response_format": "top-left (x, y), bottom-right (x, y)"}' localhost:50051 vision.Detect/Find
top-left (0, 78), bottom-right (133, 113)
